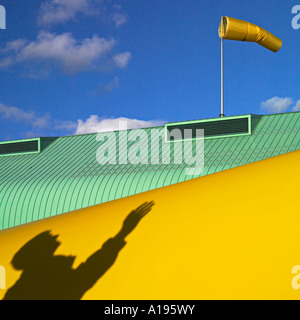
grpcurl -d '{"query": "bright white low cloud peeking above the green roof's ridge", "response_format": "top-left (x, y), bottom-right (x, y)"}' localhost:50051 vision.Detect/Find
top-left (75, 115), bottom-right (164, 134)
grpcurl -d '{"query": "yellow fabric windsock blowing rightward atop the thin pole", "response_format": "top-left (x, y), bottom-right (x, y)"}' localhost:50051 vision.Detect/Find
top-left (219, 17), bottom-right (282, 52)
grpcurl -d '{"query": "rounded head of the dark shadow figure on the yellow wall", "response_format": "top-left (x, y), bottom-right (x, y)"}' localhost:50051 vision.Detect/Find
top-left (11, 230), bottom-right (61, 270)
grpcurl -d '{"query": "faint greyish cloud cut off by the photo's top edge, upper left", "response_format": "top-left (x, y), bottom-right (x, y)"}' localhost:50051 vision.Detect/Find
top-left (38, 0), bottom-right (99, 25)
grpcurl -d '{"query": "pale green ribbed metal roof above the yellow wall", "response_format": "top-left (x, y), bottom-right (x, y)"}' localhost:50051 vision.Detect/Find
top-left (0, 112), bottom-right (300, 229)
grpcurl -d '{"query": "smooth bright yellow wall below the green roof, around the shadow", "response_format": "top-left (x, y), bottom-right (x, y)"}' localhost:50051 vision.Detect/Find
top-left (0, 151), bottom-right (300, 299)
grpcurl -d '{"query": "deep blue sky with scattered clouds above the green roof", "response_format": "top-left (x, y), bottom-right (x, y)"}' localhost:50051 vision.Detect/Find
top-left (0, 0), bottom-right (300, 140)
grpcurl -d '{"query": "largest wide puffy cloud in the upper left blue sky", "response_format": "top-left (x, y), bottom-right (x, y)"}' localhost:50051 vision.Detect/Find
top-left (0, 31), bottom-right (116, 74)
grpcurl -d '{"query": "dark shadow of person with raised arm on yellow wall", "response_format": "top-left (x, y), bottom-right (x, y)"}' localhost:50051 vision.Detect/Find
top-left (3, 201), bottom-right (154, 300)
